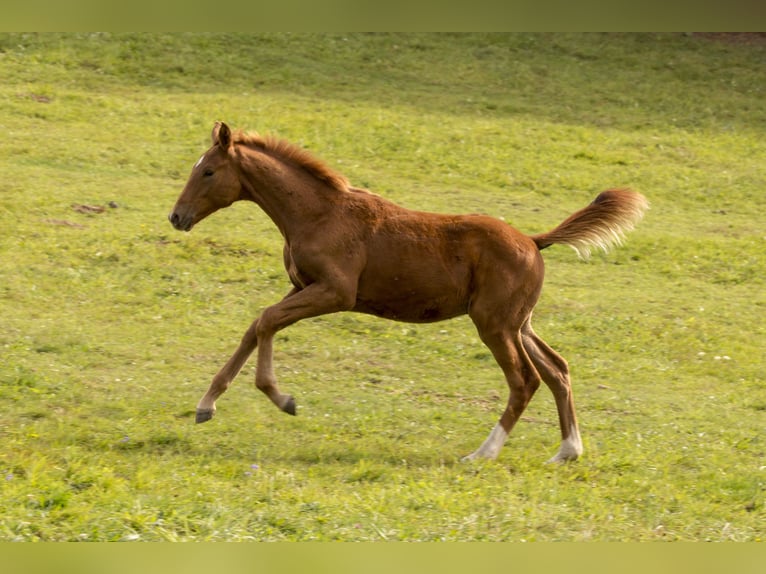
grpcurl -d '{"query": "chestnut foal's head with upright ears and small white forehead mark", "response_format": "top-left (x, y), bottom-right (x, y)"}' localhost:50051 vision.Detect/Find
top-left (168, 122), bottom-right (242, 231)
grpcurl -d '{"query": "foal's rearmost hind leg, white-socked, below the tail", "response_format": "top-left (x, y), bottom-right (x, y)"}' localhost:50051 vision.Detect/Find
top-left (521, 321), bottom-right (583, 462)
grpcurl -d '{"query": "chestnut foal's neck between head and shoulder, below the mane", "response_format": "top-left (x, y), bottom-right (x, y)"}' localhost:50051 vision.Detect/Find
top-left (241, 150), bottom-right (336, 239)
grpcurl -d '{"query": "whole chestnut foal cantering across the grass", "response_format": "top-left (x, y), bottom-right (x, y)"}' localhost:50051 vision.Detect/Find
top-left (169, 123), bottom-right (648, 462)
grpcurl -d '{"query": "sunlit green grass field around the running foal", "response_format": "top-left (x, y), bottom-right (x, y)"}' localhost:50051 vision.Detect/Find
top-left (0, 34), bottom-right (766, 541)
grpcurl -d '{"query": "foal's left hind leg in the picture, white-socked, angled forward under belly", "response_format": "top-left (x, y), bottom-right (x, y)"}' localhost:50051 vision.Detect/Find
top-left (463, 319), bottom-right (540, 460)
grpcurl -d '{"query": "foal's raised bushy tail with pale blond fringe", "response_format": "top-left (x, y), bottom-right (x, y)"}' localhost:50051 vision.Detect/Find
top-left (532, 189), bottom-right (649, 258)
